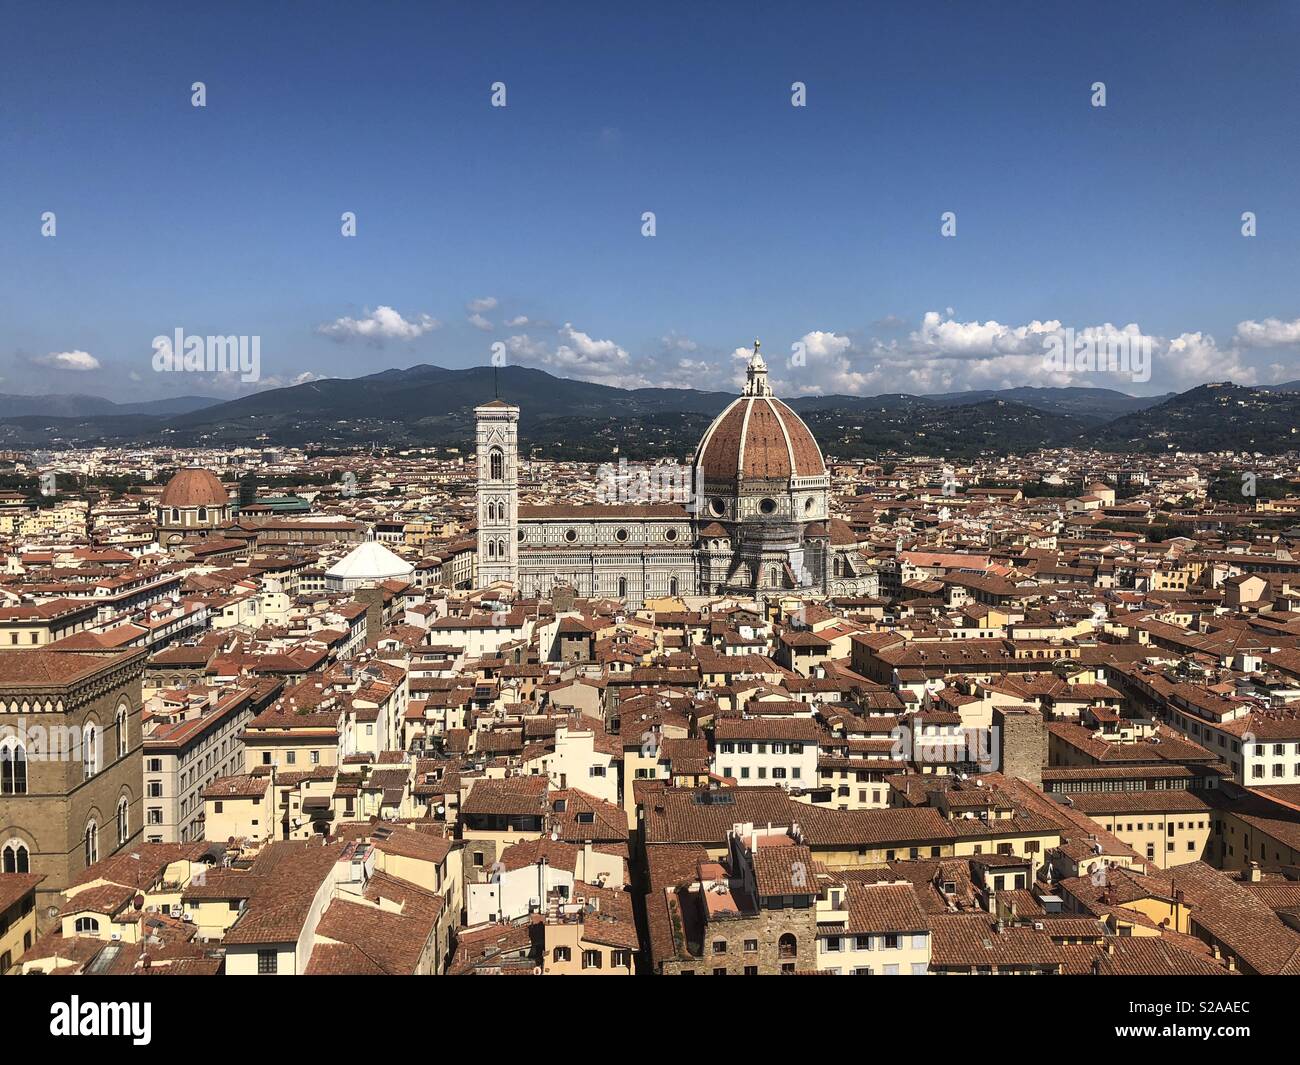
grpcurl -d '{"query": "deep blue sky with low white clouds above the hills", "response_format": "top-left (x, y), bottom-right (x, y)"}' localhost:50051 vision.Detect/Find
top-left (0, 1), bottom-right (1300, 399)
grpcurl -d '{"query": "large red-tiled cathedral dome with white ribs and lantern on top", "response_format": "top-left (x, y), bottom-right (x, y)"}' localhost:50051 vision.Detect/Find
top-left (696, 345), bottom-right (826, 484)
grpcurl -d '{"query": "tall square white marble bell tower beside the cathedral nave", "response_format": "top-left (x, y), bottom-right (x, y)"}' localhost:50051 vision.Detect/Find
top-left (475, 399), bottom-right (519, 588)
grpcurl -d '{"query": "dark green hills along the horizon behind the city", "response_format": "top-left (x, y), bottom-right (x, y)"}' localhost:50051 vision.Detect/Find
top-left (0, 365), bottom-right (1300, 459)
